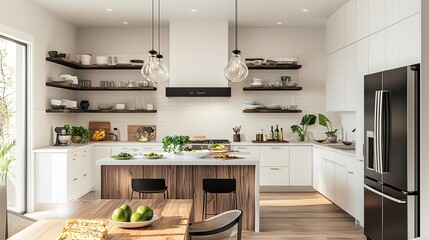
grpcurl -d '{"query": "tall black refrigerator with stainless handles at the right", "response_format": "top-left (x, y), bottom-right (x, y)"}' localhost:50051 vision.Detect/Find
top-left (364, 64), bottom-right (420, 240)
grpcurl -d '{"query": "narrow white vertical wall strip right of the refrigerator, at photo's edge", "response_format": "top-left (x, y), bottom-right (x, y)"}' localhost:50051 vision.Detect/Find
top-left (420, 1), bottom-right (429, 236)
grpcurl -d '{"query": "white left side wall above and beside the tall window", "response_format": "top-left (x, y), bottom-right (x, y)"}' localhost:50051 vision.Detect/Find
top-left (0, 0), bottom-right (76, 147)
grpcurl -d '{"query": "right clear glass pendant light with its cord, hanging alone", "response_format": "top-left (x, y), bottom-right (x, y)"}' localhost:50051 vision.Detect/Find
top-left (224, 0), bottom-right (249, 82)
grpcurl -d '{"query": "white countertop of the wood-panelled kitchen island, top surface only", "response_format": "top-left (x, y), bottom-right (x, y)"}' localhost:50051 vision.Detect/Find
top-left (95, 152), bottom-right (259, 166)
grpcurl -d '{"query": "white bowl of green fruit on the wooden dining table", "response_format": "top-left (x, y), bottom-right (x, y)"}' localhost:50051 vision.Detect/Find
top-left (109, 204), bottom-right (159, 228)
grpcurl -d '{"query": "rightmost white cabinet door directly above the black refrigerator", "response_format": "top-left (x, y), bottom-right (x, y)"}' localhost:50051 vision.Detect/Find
top-left (399, 13), bottom-right (421, 66)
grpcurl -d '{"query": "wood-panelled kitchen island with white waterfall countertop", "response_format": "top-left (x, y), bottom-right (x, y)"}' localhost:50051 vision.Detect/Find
top-left (96, 152), bottom-right (259, 231)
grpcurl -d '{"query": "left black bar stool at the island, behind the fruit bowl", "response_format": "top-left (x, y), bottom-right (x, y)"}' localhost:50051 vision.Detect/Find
top-left (131, 179), bottom-right (168, 199)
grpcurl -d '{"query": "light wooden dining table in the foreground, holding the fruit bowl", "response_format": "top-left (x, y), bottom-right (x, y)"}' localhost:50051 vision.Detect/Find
top-left (9, 199), bottom-right (193, 240)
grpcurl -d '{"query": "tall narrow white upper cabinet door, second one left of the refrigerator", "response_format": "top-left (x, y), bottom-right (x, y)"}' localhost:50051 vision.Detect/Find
top-left (344, 43), bottom-right (357, 111)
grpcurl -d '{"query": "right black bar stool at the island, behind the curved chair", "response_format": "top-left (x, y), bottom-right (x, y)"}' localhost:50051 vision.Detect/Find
top-left (202, 179), bottom-right (237, 220)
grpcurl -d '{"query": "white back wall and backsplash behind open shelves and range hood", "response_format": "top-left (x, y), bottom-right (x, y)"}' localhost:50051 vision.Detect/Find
top-left (76, 27), bottom-right (340, 141)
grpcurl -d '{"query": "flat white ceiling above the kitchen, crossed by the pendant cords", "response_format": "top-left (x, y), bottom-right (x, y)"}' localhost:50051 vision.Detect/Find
top-left (31, 0), bottom-right (347, 27)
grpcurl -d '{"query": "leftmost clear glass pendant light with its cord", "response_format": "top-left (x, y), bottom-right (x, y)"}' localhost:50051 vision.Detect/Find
top-left (141, 0), bottom-right (162, 83)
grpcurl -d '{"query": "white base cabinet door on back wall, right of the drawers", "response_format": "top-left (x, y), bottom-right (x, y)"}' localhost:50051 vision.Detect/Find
top-left (289, 146), bottom-right (313, 186)
